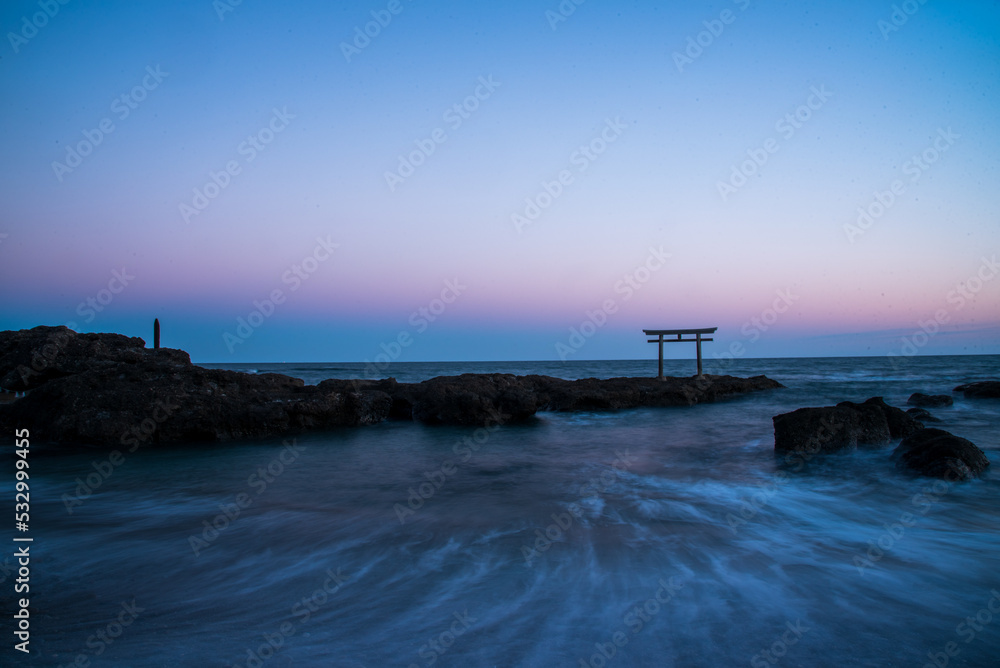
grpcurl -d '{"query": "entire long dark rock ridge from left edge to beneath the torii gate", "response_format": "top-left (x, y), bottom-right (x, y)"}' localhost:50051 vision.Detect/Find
top-left (0, 327), bottom-right (782, 447)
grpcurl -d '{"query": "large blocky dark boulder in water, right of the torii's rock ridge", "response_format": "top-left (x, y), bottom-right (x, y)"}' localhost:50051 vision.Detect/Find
top-left (772, 397), bottom-right (923, 454)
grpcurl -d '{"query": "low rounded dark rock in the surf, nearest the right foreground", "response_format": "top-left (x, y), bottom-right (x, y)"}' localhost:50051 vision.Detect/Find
top-left (892, 429), bottom-right (990, 481)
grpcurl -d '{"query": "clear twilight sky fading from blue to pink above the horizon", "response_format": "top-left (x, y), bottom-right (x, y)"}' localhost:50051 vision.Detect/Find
top-left (0, 0), bottom-right (1000, 362)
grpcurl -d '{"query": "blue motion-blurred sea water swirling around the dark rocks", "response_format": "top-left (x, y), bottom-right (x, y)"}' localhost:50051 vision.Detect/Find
top-left (7, 356), bottom-right (1000, 668)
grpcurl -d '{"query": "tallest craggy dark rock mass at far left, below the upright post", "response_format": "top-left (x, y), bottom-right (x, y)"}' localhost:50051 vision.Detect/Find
top-left (0, 327), bottom-right (391, 446)
